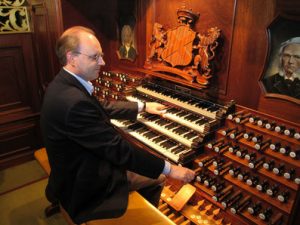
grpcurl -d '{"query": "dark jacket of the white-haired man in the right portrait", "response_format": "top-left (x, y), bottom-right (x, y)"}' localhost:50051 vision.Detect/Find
top-left (264, 73), bottom-right (300, 99)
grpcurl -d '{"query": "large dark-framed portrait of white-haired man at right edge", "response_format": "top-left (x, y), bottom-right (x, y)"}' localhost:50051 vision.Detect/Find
top-left (260, 16), bottom-right (300, 104)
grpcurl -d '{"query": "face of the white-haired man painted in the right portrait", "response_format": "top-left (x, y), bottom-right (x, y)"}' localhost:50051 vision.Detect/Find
top-left (282, 44), bottom-right (300, 76)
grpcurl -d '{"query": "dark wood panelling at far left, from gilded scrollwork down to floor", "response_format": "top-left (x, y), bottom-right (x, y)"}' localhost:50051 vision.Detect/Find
top-left (0, 34), bottom-right (41, 168)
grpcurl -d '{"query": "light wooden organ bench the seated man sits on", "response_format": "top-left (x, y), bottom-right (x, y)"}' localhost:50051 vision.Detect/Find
top-left (34, 148), bottom-right (175, 225)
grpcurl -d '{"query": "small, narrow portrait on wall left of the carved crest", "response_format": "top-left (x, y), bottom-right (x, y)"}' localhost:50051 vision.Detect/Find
top-left (116, 1), bottom-right (137, 61)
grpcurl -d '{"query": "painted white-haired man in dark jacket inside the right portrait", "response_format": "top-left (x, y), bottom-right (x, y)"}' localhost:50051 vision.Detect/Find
top-left (264, 37), bottom-right (300, 99)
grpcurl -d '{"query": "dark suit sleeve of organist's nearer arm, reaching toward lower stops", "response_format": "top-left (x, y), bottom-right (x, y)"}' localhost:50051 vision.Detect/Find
top-left (66, 101), bottom-right (164, 178)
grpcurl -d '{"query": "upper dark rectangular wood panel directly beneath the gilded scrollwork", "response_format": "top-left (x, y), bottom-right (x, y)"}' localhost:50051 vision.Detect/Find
top-left (0, 34), bottom-right (40, 113)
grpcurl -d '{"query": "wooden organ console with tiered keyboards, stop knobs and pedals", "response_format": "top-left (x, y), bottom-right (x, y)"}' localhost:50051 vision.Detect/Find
top-left (95, 72), bottom-right (300, 225)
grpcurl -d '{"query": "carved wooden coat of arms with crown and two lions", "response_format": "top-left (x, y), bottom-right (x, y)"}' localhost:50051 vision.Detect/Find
top-left (144, 7), bottom-right (221, 88)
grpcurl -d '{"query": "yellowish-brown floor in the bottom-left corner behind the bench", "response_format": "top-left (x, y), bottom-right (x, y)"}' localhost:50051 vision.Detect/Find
top-left (0, 161), bottom-right (67, 225)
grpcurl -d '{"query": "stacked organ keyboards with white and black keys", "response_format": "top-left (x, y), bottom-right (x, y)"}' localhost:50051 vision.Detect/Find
top-left (111, 80), bottom-right (233, 165)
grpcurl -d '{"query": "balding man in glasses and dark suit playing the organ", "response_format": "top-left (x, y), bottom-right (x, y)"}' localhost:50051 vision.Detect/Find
top-left (41, 27), bottom-right (195, 224)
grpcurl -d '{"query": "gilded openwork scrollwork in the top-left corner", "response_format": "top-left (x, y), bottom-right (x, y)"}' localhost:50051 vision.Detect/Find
top-left (0, 0), bottom-right (30, 33)
